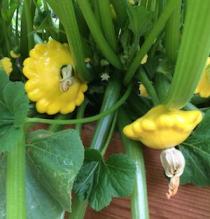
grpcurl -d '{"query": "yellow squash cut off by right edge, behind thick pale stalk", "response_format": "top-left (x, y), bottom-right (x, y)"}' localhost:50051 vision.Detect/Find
top-left (195, 58), bottom-right (210, 98)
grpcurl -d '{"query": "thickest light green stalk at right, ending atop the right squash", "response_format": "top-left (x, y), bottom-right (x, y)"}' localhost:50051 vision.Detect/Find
top-left (166, 0), bottom-right (210, 108)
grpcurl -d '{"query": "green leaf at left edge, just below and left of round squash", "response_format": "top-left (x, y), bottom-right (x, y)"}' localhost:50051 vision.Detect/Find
top-left (0, 70), bottom-right (29, 151)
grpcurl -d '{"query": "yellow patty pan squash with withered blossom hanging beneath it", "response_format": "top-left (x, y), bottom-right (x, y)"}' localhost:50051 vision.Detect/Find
top-left (123, 105), bottom-right (202, 149)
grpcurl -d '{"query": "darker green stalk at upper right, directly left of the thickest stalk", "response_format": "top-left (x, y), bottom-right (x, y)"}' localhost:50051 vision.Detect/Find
top-left (165, 0), bottom-right (182, 63)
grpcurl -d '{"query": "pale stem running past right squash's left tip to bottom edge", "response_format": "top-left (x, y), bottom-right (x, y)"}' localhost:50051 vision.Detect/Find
top-left (118, 109), bottom-right (149, 219)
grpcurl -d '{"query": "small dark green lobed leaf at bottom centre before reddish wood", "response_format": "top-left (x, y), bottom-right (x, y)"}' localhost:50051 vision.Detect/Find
top-left (74, 149), bottom-right (135, 211)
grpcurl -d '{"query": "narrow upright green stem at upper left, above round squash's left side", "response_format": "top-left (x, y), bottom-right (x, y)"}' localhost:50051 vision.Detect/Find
top-left (23, 0), bottom-right (34, 50)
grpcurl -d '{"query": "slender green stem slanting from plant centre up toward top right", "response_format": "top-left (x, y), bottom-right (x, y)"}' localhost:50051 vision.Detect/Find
top-left (124, 0), bottom-right (179, 85)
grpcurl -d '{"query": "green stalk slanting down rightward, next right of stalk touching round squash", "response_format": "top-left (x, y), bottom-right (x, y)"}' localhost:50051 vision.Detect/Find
top-left (77, 0), bottom-right (122, 69)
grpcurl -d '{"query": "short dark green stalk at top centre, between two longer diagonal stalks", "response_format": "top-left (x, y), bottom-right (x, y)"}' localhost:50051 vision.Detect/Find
top-left (98, 0), bottom-right (117, 51)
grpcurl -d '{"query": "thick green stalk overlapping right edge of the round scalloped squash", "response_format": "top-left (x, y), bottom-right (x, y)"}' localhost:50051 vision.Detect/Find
top-left (46, 0), bottom-right (93, 81)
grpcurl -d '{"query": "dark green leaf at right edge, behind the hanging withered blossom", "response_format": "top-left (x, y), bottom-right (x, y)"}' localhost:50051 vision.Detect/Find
top-left (179, 110), bottom-right (210, 186)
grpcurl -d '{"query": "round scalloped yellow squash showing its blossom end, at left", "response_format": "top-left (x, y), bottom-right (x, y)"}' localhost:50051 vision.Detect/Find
top-left (23, 40), bottom-right (87, 115)
